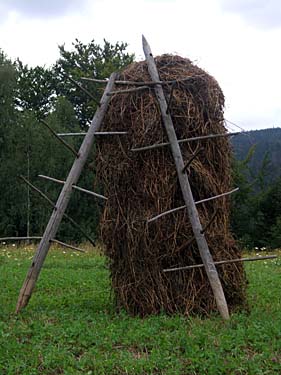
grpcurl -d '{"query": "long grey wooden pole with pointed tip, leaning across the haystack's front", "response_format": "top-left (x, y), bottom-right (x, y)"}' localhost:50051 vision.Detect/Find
top-left (142, 36), bottom-right (229, 319)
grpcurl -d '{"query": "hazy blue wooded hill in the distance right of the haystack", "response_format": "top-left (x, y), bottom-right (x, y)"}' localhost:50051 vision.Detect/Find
top-left (231, 128), bottom-right (281, 184)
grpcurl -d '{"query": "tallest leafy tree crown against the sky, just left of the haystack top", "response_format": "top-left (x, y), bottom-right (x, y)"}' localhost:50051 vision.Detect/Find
top-left (53, 39), bottom-right (134, 129)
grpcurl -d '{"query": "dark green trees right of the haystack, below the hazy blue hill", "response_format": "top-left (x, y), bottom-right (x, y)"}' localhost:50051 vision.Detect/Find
top-left (231, 146), bottom-right (281, 248)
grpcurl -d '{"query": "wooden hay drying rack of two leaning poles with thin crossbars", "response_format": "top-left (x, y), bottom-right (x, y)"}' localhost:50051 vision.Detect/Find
top-left (3, 37), bottom-right (276, 319)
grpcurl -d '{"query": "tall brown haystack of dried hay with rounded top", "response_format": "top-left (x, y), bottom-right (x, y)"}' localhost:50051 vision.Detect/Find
top-left (97, 55), bottom-right (246, 316)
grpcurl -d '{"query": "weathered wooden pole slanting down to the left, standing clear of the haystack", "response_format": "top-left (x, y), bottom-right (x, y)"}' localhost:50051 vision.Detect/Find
top-left (16, 73), bottom-right (116, 313)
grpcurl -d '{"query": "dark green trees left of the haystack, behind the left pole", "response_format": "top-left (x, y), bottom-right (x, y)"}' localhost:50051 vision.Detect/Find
top-left (0, 40), bottom-right (134, 242)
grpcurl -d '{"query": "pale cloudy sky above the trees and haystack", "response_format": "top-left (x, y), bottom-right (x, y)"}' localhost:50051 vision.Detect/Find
top-left (0, 0), bottom-right (281, 130)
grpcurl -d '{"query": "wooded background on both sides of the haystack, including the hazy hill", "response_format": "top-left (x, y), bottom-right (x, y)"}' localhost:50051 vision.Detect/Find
top-left (0, 40), bottom-right (281, 249)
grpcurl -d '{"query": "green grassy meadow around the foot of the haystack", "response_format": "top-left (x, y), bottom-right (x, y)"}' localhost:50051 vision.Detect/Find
top-left (0, 245), bottom-right (281, 375)
